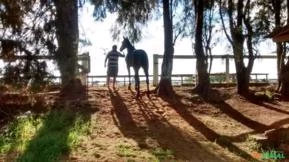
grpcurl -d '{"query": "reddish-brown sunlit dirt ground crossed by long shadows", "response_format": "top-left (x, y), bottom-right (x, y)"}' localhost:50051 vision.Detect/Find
top-left (62, 87), bottom-right (289, 162)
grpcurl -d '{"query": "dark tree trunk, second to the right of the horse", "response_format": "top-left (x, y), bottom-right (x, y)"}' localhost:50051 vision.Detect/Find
top-left (194, 1), bottom-right (210, 98)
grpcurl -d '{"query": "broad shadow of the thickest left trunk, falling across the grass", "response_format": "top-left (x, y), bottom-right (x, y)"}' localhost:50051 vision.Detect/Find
top-left (6, 81), bottom-right (96, 162)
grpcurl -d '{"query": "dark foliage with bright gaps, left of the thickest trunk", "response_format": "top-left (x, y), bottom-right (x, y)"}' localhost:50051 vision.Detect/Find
top-left (0, 0), bottom-right (56, 89)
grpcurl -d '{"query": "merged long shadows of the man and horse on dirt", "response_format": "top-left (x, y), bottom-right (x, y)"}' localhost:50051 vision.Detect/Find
top-left (109, 90), bottom-right (243, 161)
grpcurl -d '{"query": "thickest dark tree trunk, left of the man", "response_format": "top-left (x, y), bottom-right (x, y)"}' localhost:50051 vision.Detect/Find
top-left (54, 0), bottom-right (79, 88)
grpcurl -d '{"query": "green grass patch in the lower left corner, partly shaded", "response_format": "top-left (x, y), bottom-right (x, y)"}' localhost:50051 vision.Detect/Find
top-left (0, 109), bottom-right (90, 162)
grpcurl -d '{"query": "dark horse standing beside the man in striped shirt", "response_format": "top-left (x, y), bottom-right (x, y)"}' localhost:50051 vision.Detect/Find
top-left (120, 37), bottom-right (149, 98)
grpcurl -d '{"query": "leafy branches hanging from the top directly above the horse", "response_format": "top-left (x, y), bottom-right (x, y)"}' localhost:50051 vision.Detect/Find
top-left (91, 0), bottom-right (157, 43)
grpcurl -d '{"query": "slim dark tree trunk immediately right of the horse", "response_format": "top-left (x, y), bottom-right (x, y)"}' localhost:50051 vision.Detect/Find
top-left (158, 0), bottom-right (174, 97)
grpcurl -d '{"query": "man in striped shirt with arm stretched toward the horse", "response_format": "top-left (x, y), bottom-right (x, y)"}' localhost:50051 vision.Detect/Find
top-left (104, 45), bottom-right (124, 88)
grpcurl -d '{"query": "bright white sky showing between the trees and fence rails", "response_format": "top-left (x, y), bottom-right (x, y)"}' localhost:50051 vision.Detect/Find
top-left (54, 3), bottom-right (277, 78)
